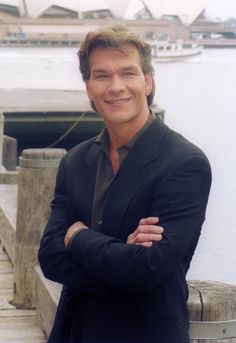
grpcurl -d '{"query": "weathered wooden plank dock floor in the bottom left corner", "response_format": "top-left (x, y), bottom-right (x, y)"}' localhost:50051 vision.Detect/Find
top-left (0, 244), bottom-right (47, 343)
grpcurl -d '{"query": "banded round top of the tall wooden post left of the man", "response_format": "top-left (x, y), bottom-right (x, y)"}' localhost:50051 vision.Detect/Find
top-left (19, 148), bottom-right (66, 169)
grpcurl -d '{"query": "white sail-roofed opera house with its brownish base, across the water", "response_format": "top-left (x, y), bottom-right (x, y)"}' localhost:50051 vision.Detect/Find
top-left (0, 0), bottom-right (210, 45)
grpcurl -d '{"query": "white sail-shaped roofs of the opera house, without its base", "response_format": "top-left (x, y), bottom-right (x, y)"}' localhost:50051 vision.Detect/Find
top-left (0, 0), bottom-right (206, 24)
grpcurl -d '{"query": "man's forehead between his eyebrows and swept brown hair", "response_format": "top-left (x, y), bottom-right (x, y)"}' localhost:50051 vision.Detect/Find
top-left (89, 44), bottom-right (141, 71)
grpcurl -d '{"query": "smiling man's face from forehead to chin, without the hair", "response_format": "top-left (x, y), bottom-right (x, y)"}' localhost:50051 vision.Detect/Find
top-left (86, 45), bottom-right (152, 125)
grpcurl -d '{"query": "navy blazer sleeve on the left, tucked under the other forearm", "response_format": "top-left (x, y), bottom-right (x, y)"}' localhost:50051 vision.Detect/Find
top-left (38, 158), bottom-right (105, 292)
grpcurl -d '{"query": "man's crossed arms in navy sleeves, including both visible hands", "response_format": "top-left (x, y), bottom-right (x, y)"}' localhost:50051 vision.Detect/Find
top-left (39, 156), bottom-right (211, 292)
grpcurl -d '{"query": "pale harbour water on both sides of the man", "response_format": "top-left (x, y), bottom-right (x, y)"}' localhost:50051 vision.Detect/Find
top-left (0, 48), bottom-right (236, 285)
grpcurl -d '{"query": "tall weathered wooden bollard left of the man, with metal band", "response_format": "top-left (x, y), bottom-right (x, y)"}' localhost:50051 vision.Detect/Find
top-left (13, 149), bottom-right (66, 308)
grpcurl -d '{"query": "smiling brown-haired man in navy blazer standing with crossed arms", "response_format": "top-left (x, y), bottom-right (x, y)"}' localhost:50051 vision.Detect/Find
top-left (39, 26), bottom-right (211, 343)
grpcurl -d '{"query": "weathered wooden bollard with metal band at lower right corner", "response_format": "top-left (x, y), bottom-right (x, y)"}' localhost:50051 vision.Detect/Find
top-left (188, 281), bottom-right (236, 343)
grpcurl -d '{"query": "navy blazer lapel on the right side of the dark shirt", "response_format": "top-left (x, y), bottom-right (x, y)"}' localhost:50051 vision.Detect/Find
top-left (102, 118), bottom-right (168, 236)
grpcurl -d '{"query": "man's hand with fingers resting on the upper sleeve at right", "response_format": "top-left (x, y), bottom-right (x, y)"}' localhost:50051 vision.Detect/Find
top-left (126, 217), bottom-right (164, 248)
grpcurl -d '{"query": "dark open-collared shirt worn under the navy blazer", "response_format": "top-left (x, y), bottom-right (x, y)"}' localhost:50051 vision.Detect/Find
top-left (91, 113), bottom-right (156, 231)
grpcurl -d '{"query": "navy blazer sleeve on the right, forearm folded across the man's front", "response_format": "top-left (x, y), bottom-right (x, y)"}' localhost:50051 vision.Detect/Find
top-left (69, 155), bottom-right (211, 292)
